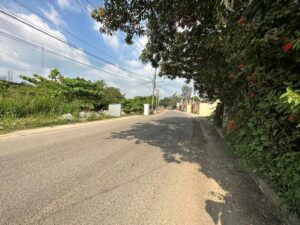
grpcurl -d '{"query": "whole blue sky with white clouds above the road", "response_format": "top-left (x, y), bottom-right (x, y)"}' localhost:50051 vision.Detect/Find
top-left (0, 0), bottom-right (188, 97)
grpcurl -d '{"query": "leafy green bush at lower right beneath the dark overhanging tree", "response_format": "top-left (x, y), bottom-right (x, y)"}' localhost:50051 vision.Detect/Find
top-left (226, 89), bottom-right (300, 214)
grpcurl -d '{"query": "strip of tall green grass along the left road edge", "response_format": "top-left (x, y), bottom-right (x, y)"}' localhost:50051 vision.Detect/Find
top-left (0, 94), bottom-right (121, 134)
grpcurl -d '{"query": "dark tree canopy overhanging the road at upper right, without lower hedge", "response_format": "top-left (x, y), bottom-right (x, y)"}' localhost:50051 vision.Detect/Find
top-left (92, 0), bottom-right (300, 101)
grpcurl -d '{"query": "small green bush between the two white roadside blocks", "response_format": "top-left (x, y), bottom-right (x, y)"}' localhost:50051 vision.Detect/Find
top-left (122, 96), bottom-right (151, 113)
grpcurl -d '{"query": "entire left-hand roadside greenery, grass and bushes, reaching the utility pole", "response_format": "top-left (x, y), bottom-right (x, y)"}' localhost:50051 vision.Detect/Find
top-left (0, 69), bottom-right (151, 132)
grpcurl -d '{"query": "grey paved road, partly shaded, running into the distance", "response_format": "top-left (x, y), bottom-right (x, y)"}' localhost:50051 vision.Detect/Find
top-left (0, 111), bottom-right (281, 225)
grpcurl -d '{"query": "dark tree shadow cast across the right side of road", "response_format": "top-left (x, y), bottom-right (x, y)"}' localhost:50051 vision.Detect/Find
top-left (111, 116), bottom-right (282, 225)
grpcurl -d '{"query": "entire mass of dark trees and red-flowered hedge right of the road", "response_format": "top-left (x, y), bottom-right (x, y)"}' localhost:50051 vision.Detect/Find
top-left (92, 0), bottom-right (300, 215)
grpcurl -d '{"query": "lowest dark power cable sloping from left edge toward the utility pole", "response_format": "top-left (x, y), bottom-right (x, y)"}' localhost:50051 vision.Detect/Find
top-left (0, 31), bottom-right (150, 82)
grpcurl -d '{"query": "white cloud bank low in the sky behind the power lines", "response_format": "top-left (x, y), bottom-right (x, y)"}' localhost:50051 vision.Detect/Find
top-left (0, 8), bottom-right (182, 97)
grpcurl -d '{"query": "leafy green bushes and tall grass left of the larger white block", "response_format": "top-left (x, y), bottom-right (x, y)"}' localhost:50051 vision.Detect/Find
top-left (0, 69), bottom-right (124, 121)
